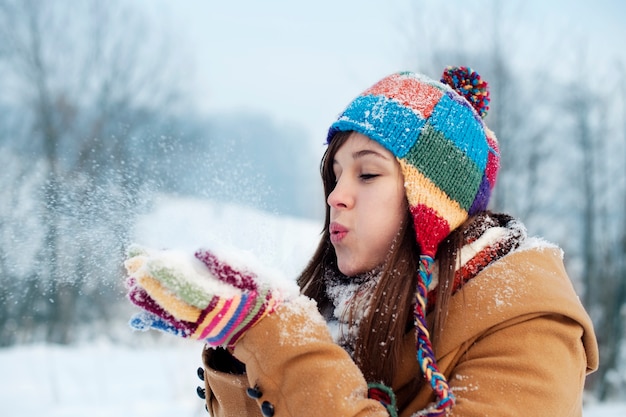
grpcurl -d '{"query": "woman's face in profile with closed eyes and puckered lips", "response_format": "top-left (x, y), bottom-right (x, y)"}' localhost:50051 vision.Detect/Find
top-left (327, 132), bottom-right (408, 276)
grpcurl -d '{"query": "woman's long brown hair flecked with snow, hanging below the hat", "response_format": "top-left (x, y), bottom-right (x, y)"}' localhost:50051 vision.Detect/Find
top-left (298, 132), bottom-right (461, 386)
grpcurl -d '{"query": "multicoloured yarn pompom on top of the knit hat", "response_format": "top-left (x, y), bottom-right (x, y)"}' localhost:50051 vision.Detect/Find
top-left (441, 66), bottom-right (489, 119)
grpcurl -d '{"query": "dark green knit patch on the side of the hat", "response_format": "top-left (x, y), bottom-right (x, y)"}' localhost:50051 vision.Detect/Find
top-left (405, 123), bottom-right (482, 210)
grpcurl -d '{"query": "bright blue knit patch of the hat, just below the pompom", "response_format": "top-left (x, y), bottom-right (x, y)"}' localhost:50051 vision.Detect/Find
top-left (429, 94), bottom-right (488, 171)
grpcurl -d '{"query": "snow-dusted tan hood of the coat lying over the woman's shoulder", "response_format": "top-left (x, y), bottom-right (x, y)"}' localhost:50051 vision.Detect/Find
top-left (442, 238), bottom-right (595, 356)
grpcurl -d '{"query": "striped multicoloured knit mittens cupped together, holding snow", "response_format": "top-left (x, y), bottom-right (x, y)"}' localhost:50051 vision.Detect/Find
top-left (124, 246), bottom-right (284, 347)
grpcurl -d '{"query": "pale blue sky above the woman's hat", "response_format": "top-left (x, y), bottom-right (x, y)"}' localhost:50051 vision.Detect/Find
top-left (149, 0), bottom-right (626, 143)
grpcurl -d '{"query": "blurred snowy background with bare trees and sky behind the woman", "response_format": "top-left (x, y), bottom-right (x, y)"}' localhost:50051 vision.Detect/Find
top-left (0, 0), bottom-right (626, 417)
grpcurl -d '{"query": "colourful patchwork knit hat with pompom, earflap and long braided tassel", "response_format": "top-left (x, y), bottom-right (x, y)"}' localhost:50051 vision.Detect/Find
top-left (327, 67), bottom-right (500, 416)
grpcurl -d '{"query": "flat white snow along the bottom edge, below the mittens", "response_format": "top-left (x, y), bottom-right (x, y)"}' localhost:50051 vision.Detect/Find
top-left (0, 341), bottom-right (626, 417)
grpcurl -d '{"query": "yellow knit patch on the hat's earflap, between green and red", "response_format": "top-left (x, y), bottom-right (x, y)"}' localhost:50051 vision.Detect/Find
top-left (398, 159), bottom-right (467, 230)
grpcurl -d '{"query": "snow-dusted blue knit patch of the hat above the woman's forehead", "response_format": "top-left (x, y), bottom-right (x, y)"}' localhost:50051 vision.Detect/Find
top-left (330, 95), bottom-right (426, 158)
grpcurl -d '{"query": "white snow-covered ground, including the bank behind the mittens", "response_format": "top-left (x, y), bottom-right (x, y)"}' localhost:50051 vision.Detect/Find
top-left (0, 198), bottom-right (626, 417)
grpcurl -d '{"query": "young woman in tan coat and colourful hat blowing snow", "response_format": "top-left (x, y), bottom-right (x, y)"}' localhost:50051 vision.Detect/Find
top-left (126, 67), bottom-right (598, 417)
